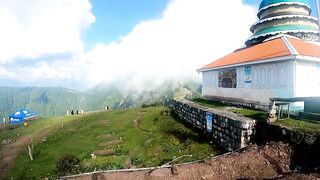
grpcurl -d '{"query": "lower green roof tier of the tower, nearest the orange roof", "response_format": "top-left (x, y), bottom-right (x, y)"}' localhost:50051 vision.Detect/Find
top-left (253, 25), bottom-right (318, 36)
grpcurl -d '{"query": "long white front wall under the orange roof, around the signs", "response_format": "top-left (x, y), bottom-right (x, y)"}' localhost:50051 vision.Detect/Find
top-left (202, 60), bottom-right (294, 105)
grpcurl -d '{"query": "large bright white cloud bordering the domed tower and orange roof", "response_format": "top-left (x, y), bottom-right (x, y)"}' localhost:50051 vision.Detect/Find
top-left (84, 0), bottom-right (256, 88)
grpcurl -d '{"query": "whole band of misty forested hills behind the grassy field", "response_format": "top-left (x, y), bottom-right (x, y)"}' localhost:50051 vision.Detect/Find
top-left (0, 81), bottom-right (199, 117)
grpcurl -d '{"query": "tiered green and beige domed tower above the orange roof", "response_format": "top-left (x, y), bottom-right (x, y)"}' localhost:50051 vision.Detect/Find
top-left (246, 0), bottom-right (319, 46)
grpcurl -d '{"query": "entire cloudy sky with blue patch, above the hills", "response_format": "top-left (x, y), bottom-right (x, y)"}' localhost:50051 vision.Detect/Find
top-left (0, 0), bottom-right (318, 90)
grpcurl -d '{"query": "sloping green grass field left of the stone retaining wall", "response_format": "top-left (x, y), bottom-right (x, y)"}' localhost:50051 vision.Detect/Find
top-left (0, 107), bottom-right (219, 179)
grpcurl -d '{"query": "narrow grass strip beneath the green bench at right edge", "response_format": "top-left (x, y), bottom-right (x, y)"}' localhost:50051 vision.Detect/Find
top-left (274, 118), bottom-right (320, 135)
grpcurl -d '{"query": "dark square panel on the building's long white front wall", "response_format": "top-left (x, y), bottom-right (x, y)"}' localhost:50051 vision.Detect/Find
top-left (218, 69), bottom-right (237, 88)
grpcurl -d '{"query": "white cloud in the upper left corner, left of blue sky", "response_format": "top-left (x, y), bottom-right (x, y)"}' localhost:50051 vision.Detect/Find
top-left (0, 0), bottom-right (95, 63)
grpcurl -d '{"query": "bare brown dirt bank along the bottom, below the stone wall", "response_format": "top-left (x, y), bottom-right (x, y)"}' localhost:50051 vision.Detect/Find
top-left (66, 143), bottom-right (317, 180)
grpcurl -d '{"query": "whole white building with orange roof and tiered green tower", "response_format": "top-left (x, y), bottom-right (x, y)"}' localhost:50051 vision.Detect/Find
top-left (197, 0), bottom-right (320, 107)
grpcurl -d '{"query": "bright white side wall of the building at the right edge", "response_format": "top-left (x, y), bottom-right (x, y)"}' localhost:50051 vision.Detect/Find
top-left (295, 61), bottom-right (320, 97)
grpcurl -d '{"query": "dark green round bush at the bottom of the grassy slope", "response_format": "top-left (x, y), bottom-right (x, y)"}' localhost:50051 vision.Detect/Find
top-left (56, 155), bottom-right (81, 176)
